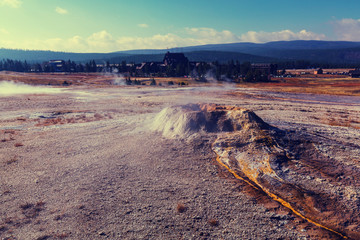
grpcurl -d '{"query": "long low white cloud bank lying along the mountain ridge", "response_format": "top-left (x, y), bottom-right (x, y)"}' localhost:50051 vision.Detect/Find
top-left (0, 28), bottom-right (325, 52)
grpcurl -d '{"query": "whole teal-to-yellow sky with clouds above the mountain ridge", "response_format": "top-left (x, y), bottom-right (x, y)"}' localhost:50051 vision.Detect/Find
top-left (0, 0), bottom-right (360, 52)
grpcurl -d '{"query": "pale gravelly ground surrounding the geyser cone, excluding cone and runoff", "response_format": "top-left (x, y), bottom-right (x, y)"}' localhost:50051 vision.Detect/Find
top-left (0, 82), bottom-right (360, 240)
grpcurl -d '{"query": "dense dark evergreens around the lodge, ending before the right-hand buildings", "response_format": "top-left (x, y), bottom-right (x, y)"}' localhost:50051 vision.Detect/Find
top-left (0, 59), bottom-right (277, 80)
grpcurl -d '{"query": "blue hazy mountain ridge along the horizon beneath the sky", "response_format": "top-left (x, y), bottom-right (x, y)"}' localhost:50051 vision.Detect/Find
top-left (0, 40), bottom-right (360, 64)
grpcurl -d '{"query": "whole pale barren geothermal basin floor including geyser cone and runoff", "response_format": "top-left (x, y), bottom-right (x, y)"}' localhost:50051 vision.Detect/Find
top-left (0, 83), bottom-right (360, 239)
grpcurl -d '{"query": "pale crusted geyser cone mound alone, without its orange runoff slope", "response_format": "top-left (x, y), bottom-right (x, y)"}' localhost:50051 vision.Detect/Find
top-left (152, 104), bottom-right (268, 138)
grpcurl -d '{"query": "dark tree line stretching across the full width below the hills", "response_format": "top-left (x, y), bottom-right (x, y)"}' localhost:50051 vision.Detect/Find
top-left (0, 59), bottom-right (357, 82)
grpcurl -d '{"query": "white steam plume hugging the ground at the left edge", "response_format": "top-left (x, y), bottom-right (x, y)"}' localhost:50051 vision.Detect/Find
top-left (0, 81), bottom-right (64, 96)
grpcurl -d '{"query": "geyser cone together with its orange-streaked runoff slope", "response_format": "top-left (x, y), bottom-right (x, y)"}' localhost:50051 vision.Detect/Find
top-left (152, 104), bottom-right (360, 239)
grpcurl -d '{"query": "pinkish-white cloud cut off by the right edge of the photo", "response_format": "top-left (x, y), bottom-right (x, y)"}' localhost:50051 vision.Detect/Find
top-left (332, 18), bottom-right (360, 41)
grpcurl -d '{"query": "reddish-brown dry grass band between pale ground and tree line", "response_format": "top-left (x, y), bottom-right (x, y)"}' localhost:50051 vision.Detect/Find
top-left (0, 69), bottom-right (360, 96)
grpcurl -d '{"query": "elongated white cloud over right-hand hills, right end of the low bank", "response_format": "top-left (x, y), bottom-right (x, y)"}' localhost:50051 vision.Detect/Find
top-left (240, 30), bottom-right (326, 43)
